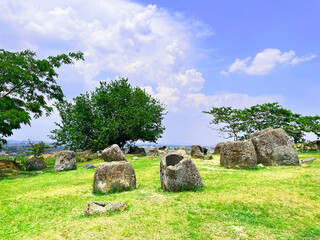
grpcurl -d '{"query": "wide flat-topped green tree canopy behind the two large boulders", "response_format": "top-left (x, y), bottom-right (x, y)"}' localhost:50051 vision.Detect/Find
top-left (203, 103), bottom-right (320, 143)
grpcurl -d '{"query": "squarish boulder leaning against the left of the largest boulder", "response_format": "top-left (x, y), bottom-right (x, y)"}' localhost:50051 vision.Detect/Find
top-left (220, 141), bottom-right (257, 168)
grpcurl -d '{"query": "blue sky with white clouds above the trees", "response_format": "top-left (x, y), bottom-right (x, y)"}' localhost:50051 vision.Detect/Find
top-left (0, 0), bottom-right (320, 145)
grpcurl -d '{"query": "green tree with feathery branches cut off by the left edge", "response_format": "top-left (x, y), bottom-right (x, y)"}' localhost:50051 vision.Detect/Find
top-left (0, 49), bottom-right (84, 148)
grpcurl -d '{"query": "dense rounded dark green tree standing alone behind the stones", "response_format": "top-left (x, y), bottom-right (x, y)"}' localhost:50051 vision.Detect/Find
top-left (51, 78), bottom-right (166, 151)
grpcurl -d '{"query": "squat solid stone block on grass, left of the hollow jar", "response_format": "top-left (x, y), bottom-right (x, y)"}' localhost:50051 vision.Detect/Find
top-left (93, 161), bottom-right (136, 193)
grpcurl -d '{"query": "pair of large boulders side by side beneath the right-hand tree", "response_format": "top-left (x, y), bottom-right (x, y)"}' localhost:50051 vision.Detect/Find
top-left (220, 128), bottom-right (299, 168)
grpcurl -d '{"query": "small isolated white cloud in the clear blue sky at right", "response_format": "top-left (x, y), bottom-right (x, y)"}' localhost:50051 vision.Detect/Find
top-left (221, 48), bottom-right (316, 75)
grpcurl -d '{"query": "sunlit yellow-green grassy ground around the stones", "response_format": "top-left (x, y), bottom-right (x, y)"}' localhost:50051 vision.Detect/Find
top-left (0, 153), bottom-right (320, 239)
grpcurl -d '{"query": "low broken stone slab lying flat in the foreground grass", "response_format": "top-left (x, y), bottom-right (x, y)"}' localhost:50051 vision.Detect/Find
top-left (84, 201), bottom-right (128, 216)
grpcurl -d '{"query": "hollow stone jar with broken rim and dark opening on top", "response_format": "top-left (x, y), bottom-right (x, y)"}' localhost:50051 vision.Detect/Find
top-left (160, 153), bottom-right (203, 192)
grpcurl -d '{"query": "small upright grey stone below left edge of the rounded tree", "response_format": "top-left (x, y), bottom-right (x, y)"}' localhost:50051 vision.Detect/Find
top-left (54, 151), bottom-right (77, 172)
